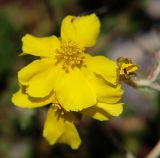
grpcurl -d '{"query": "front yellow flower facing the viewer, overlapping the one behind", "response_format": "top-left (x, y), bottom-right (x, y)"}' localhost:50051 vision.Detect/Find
top-left (18, 14), bottom-right (122, 111)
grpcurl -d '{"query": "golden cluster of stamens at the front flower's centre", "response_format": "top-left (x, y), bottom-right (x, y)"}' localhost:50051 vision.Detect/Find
top-left (56, 41), bottom-right (84, 72)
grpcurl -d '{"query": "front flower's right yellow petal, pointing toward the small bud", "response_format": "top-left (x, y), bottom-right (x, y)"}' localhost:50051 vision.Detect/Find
top-left (85, 55), bottom-right (117, 84)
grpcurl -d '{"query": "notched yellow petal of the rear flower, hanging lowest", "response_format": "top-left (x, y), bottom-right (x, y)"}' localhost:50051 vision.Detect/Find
top-left (43, 107), bottom-right (81, 149)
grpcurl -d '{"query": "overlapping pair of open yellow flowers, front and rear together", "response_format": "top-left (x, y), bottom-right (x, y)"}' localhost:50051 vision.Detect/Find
top-left (12, 14), bottom-right (123, 149)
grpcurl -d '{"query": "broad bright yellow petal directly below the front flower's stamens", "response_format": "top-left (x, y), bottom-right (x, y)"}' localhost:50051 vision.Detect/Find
top-left (55, 67), bottom-right (96, 111)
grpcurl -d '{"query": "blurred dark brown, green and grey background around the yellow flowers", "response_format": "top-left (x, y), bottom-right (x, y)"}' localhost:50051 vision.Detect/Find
top-left (0, 0), bottom-right (160, 158)
